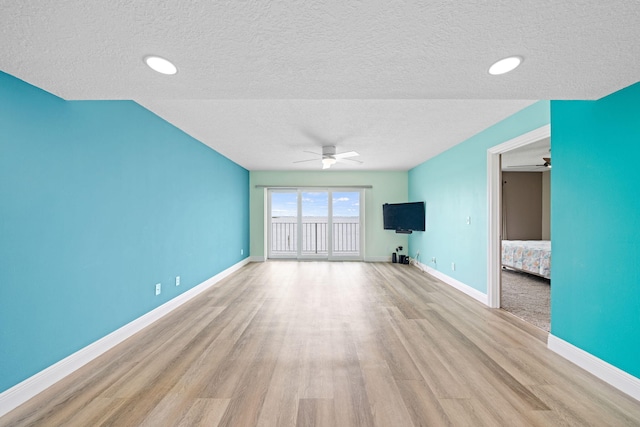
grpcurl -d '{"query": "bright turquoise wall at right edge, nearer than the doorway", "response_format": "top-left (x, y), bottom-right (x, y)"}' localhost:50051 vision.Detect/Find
top-left (551, 83), bottom-right (640, 377)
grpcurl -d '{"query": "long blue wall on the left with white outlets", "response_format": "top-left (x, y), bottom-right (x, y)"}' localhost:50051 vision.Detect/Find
top-left (0, 73), bottom-right (249, 392)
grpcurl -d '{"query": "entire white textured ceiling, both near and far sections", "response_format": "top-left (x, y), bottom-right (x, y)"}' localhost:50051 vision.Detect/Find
top-left (0, 0), bottom-right (640, 170)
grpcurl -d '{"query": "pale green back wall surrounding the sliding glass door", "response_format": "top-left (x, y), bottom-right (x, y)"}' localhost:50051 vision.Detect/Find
top-left (249, 170), bottom-right (409, 261)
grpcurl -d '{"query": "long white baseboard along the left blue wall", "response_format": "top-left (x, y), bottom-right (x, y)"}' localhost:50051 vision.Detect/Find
top-left (0, 258), bottom-right (249, 417)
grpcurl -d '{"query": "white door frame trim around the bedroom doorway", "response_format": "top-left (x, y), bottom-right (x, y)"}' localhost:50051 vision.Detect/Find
top-left (487, 124), bottom-right (551, 308)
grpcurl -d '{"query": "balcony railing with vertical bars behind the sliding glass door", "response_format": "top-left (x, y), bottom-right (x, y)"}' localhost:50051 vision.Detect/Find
top-left (271, 222), bottom-right (360, 256)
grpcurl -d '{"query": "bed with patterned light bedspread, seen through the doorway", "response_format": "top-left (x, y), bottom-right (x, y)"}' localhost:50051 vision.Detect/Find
top-left (502, 240), bottom-right (551, 279)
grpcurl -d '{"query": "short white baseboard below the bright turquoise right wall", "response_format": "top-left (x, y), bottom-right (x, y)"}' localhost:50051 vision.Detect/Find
top-left (547, 334), bottom-right (640, 400)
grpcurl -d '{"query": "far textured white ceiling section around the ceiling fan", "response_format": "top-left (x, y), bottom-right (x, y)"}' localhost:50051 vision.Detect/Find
top-left (142, 99), bottom-right (530, 170)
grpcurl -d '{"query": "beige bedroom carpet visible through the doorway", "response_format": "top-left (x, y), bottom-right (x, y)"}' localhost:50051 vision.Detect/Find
top-left (500, 269), bottom-right (551, 332)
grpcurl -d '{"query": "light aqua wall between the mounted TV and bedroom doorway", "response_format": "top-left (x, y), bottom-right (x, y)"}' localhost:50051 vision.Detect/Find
top-left (409, 101), bottom-right (555, 293)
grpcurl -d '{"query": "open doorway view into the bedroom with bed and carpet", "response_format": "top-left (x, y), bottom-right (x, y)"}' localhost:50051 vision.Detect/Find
top-left (500, 142), bottom-right (551, 332)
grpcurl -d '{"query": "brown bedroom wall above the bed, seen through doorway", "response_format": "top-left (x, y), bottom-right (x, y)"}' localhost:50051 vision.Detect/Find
top-left (502, 172), bottom-right (542, 240)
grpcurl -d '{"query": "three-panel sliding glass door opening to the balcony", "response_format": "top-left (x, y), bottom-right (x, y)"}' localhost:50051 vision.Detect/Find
top-left (267, 189), bottom-right (363, 260)
